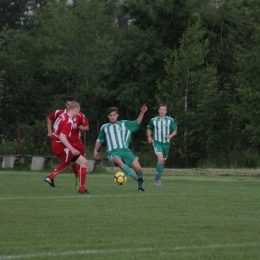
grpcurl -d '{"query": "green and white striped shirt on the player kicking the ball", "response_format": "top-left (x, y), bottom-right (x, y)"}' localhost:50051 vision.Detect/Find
top-left (97, 120), bottom-right (139, 152)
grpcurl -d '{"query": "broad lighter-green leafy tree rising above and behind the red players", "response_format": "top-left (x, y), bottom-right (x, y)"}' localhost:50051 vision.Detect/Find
top-left (36, 0), bottom-right (120, 119)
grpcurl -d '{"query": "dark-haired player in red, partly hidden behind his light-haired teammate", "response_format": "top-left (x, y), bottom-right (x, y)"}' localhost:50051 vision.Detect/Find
top-left (47, 97), bottom-right (89, 188)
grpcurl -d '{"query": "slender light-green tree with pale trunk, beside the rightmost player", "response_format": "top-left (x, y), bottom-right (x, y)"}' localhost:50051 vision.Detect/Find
top-left (157, 19), bottom-right (217, 167)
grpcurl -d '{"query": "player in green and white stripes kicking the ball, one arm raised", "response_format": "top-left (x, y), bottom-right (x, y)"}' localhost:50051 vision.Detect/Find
top-left (94, 105), bottom-right (147, 191)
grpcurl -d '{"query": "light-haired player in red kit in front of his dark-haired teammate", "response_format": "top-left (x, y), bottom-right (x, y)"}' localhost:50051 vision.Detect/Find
top-left (44, 101), bottom-right (88, 194)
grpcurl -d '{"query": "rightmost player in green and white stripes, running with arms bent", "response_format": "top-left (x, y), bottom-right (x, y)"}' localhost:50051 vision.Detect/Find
top-left (147, 104), bottom-right (177, 186)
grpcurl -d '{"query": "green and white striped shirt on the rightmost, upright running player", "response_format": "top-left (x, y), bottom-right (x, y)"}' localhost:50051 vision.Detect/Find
top-left (147, 116), bottom-right (177, 143)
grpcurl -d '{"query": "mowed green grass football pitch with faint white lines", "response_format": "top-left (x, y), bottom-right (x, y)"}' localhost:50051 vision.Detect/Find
top-left (0, 169), bottom-right (260, 260)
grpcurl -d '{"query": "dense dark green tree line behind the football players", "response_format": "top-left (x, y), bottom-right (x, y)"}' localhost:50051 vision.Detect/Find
top-left (0, 0), bottom-right (260, 167)
